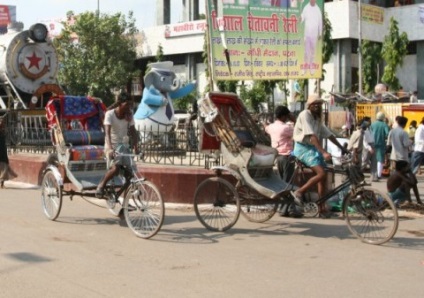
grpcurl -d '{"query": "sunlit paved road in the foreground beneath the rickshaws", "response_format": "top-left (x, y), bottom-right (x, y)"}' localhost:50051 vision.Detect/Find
top-left (0, 183), bottom-right (424, 298)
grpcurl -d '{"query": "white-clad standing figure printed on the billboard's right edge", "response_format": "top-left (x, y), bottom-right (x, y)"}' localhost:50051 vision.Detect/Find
top-left (300, 0), bottom-right (323, 75)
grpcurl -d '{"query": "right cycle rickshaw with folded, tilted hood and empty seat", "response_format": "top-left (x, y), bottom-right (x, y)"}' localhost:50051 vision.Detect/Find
top-left (194, 92), bottom-right (398, 244)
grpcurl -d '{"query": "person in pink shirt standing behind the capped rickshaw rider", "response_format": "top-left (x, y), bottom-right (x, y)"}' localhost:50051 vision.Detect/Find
top-left (265, 106), bottom-right (296, 182)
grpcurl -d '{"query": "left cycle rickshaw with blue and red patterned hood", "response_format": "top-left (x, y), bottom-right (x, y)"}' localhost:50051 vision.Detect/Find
top-left (41, 96), bottom-right (165, 239)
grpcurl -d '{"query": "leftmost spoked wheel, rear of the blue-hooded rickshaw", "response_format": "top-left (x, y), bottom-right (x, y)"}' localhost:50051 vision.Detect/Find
top-left (41, 171), bottom-right (62, 220)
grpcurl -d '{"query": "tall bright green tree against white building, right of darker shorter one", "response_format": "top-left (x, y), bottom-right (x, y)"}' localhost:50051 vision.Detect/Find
top-left (381, 17), bottom-right (409, 90)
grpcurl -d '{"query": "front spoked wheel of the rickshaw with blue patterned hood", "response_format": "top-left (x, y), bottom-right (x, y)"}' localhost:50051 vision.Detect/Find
top-left (123, 180), bottom-right (165, 239)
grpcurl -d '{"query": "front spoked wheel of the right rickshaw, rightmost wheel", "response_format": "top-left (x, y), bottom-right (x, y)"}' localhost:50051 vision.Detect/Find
top-left (343, 188), bottom-right (399, 244)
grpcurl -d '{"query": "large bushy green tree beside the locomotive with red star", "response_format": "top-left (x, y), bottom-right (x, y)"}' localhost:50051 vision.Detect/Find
top-left (54, 11), bottom-right (138, 104)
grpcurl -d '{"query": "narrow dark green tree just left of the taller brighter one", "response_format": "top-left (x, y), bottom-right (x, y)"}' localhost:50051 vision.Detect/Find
top-left (360, 40), bottom-right (381, 93)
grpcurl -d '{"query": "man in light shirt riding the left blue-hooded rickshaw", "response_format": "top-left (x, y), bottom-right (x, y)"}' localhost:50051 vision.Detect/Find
top-left (96, 93), bottom-right (138, 198)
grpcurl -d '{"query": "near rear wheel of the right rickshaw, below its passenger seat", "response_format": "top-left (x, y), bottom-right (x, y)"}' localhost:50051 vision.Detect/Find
top-left (194, 177), bottom-right (240, 231)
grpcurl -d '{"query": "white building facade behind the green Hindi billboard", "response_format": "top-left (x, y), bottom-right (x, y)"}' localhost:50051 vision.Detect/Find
top-left (138, 0), bottom-right (424, 101)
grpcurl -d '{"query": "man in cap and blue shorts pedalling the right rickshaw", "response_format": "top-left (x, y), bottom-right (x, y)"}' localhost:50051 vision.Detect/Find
top-left (292, 94), bottom-right (347, 215)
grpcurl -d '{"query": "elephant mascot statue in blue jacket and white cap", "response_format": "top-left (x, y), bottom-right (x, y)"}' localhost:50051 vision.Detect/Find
top-left (134, 61), bottom-right (196, 145)
